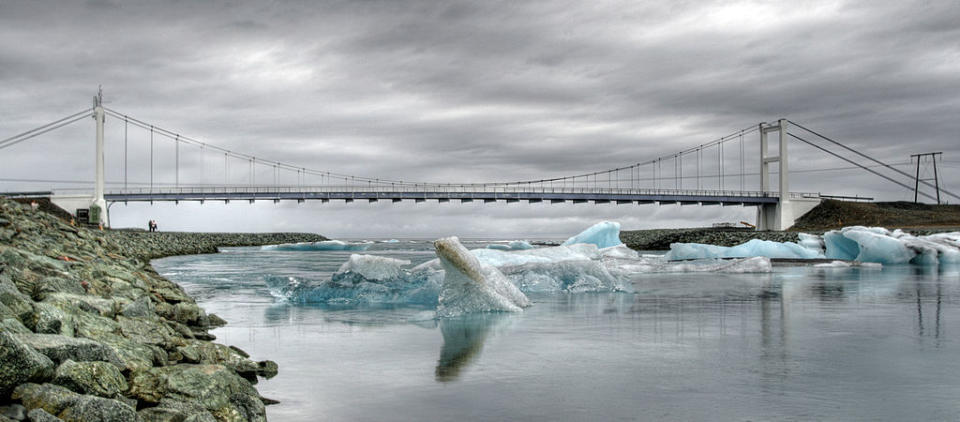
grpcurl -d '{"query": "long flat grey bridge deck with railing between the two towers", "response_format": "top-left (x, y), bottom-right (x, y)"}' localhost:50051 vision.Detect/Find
top-left (104, 190), bottom-right (780, 205)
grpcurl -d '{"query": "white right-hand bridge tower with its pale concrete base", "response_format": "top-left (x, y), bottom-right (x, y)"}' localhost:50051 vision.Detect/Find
top-left (757, 119), bottom-right (820, 230)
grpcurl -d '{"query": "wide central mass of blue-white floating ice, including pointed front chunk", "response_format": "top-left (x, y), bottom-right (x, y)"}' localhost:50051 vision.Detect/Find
top-left (267, 221), bottom-right (771, 310)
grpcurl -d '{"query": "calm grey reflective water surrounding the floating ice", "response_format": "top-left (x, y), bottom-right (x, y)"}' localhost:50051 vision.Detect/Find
top-left (154, 241), bottom-right (960, 421)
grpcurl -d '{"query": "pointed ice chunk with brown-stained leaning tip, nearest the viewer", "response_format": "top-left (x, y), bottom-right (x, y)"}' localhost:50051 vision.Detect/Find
top-left (434, 237), bottom-right (530, 317)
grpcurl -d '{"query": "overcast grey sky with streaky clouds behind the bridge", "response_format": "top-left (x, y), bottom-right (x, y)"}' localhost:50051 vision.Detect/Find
top-left (0, 0), bottom-right (960, 237)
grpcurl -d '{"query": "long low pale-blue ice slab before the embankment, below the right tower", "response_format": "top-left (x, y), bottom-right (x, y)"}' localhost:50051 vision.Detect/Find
top-left (666, 239), bottom-right (823, 260)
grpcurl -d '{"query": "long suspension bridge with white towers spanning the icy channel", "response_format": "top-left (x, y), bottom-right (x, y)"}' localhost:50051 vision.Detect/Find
top-left (0, 90), bottom-right (960, 230)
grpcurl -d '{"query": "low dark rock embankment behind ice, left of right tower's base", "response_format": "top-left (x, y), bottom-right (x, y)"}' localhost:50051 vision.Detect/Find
top-left (620, 227), bottom-right (800, 251)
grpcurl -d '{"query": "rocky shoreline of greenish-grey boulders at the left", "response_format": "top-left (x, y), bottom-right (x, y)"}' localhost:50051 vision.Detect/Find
top-left (0, 198), bottom-right (324, 422)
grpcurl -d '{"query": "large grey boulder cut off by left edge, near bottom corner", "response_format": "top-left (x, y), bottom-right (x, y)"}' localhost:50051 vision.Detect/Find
top-left (0, 331), bottom-right (54, 400)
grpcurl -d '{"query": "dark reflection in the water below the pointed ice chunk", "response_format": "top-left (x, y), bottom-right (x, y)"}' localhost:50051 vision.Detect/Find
top-left (435, 314), bottom-right (511, 382)
